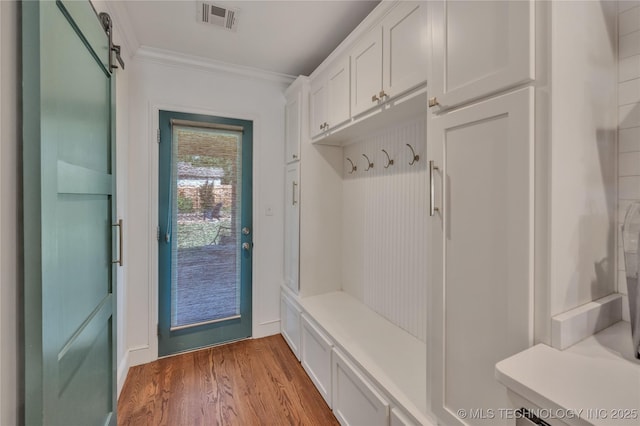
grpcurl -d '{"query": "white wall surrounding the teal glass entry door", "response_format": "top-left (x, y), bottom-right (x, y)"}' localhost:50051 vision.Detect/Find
top-left (126, 52), bottom-right (290, 365)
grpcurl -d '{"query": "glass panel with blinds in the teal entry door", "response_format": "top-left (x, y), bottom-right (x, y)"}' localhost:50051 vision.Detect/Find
top-left (167, 124), bottom-right (242, 329)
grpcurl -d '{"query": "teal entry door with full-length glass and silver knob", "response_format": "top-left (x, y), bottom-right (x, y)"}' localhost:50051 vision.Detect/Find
top-left (158, 111), bottom-right (253, 356)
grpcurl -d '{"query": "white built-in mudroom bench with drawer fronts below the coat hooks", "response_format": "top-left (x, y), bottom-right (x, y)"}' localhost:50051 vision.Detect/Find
top-left (282, 288), bottom-right (435, 426)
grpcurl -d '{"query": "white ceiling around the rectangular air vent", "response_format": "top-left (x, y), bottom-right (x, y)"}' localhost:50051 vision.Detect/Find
top-left (124, 0), bottom-right (379, 76)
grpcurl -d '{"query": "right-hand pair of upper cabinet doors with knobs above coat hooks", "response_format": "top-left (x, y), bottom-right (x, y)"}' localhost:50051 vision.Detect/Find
top-left (351, 1), bottom-right (428, 116)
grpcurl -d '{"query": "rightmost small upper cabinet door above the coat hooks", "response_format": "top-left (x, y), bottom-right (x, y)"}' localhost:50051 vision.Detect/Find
top-left (382, 1), bottom-right (428, 97)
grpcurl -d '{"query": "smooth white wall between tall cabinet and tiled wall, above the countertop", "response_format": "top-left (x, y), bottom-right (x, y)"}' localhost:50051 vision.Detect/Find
top-left (549, 1), bottom-right (617, 316)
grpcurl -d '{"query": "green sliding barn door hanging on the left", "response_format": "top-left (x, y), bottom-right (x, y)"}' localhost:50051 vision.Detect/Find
top-left (22, 1), bottom-right (119, 426)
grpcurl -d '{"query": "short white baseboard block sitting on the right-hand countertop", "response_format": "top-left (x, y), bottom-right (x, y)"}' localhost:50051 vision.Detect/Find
top-left (551, 293), bottom-right (623, 350)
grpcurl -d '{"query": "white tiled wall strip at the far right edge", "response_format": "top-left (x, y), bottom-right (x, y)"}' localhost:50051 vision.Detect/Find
top-left (618, 1), bottom-right (640, 321)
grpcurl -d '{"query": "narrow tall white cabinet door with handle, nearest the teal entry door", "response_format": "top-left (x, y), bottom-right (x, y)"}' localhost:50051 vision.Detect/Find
top-left (284, 162), bottom-right (300, 293)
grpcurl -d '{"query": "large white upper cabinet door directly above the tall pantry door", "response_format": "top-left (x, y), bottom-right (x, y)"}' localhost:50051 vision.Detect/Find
top-left (428, 0), bottom-right (535, 111)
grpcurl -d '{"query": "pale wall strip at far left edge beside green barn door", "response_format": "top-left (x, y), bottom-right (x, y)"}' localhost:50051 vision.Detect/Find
top-left (0, 1), bottom-right (22, 425)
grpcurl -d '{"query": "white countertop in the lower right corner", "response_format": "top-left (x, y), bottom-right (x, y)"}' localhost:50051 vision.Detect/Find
top-left (496, 321), bottom-right (640, 426)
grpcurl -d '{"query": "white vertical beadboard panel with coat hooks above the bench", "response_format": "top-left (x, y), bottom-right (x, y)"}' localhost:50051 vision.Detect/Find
top-left (343, 119), bottom-right (428, 341)
